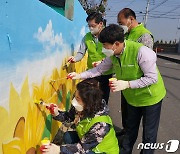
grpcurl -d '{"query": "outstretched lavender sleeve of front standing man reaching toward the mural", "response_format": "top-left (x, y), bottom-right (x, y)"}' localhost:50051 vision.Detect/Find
top-left (80, 57), bottom-right (112, 79)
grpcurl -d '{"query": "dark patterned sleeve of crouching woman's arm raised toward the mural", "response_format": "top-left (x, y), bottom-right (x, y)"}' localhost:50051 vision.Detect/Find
top-left (53, 106), bottom-right (76, 122)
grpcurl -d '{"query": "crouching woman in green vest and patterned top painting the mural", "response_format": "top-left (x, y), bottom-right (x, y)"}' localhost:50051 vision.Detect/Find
top-left (42, 79), bottom-right (119, 154)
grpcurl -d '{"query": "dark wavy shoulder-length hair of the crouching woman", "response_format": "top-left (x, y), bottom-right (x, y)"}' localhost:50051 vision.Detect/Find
top-left (76, 78), bottom-right (104, 117)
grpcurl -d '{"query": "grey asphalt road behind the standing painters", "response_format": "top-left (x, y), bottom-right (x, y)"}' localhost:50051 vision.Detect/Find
top-left (109, 58), bottom-right (180, 154)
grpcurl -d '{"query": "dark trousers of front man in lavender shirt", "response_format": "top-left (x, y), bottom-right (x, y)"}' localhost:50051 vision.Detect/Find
top-left (121, 101), bottom-right (162, 154)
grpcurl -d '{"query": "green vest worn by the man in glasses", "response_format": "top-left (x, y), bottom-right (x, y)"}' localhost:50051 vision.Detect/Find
top-left (85, 32), bottom-right (112, 75)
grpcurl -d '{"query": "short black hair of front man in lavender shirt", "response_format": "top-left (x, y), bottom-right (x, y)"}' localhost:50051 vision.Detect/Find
top-left (98, 24), bottom-right (124, 44)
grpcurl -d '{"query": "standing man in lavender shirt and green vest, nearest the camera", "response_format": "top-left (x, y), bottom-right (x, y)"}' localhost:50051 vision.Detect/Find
top-left (68, 24), bottom-right (166, 154)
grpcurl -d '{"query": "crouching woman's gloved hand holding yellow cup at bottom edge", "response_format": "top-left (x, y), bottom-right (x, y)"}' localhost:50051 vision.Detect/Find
top-left (41, 143), bottom-right (61, 154)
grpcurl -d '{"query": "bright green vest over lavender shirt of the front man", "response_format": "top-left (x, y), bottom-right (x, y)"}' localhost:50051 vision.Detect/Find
top-left (111, 41), bottom-right (166, 107)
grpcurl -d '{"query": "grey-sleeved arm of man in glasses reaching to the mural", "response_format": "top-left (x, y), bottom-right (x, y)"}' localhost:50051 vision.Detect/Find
top-left (74, 37), bottom-right (87, 62)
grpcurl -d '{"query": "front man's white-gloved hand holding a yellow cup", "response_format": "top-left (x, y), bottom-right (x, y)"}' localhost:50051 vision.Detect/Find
top-left (110, 80), bottom-right (130, 92)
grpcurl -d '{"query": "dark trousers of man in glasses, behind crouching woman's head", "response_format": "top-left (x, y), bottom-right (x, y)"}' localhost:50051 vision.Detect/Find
top-left (95, 74), bottom-right (112, 104)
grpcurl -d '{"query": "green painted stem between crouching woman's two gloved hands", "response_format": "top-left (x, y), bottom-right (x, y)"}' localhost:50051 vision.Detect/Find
top-left (42, 114), bottom-right (52, 139)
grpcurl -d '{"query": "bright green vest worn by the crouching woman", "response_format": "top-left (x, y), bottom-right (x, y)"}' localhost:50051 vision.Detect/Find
top-left (76, 115), bottom-right (119, 154)
